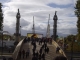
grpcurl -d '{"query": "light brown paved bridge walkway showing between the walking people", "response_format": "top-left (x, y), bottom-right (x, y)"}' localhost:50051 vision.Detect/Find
top-left (18, 42), bottom-right (61, 60)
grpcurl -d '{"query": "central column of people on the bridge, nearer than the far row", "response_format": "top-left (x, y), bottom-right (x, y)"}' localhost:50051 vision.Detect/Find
top-left (31, 38), bottom-right (49, 60)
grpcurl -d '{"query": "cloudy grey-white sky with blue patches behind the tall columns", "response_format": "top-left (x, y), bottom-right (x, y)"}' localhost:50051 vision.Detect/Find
top-left (0, 0), bottom-right (77, 36)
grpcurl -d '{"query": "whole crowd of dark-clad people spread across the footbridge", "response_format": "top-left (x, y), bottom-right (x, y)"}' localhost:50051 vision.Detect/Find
top-left (16, 37), bottom-right (67, 60)
